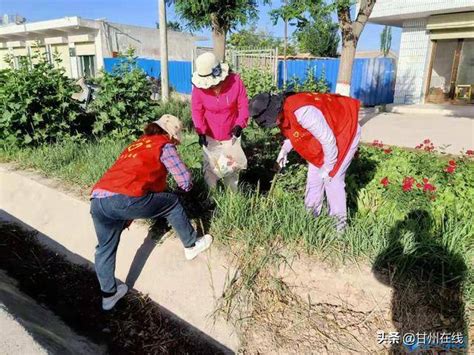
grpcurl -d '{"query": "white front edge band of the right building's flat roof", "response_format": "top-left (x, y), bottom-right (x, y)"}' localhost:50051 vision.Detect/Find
top-left (370, 0), bottom-right (474, 18)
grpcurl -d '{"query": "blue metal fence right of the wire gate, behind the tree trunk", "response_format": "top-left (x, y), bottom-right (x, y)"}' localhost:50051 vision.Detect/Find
top-left (278, 58), bottom-right (395, 106)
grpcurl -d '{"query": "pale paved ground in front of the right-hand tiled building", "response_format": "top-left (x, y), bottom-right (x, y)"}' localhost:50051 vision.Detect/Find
top-left (360, 112), bottom-right (474, 154)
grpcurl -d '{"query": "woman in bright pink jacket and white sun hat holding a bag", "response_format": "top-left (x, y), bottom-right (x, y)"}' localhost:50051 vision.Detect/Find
top-left (191, 53), bottom-right (249, 191)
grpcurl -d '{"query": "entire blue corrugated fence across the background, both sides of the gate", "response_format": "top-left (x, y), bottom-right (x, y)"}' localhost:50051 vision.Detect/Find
top-left (104, 58), bottom-right (395, 106)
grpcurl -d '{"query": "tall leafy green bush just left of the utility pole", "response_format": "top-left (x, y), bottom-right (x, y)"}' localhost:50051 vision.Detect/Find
top-left (91, 50), bottom-right (158, 139)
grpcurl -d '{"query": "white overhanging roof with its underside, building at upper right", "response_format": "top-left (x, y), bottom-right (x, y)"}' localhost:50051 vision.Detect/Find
top-left (369, 0), bottom-right (474, 27)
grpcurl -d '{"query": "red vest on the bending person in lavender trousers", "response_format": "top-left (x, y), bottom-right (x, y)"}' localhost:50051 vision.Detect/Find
top-left (280, 93), bottom-right (360, 176)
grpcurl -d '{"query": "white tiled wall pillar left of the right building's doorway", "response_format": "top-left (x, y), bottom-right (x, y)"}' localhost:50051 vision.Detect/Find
top-left (394, 20), bottom-right (431, 104)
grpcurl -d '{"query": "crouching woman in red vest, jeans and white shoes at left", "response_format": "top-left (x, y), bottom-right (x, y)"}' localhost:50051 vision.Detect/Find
top-left (91, 115), bottom-right (212, 310)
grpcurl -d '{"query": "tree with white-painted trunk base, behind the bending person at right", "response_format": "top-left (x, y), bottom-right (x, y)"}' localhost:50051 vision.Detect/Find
top-left (271, 0), bottom-right (376, 96)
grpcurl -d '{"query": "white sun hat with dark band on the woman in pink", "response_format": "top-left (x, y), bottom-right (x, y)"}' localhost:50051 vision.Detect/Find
top-left (191, 52), bottom-right (229, 89)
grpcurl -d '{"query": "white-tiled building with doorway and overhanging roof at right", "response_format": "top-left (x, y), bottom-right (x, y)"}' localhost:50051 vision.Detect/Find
top-left (369, 0), bottom-right (474, 104)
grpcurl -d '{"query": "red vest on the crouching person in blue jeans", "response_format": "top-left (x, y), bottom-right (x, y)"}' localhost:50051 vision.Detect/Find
top-left (92, 135), bottom-right (171, 197)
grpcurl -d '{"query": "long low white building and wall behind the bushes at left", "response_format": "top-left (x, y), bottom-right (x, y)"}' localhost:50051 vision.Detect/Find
top-left (0, 17), bottom-right (202, 78)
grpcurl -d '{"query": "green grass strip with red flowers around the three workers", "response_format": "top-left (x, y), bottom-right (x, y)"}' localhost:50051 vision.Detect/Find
top-left (0, 128), bottom-right (474, 350)
